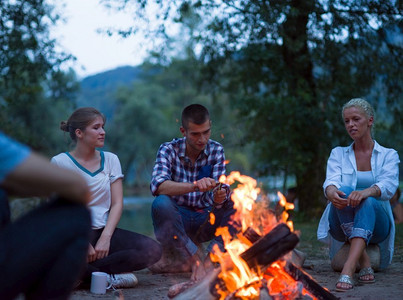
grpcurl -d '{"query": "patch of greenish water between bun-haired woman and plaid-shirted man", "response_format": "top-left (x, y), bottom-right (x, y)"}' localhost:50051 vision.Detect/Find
top-left (118, 197), bottom-right (154, 237)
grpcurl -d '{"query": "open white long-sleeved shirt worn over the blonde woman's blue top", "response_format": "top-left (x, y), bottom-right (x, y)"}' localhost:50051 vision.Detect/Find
top-left (317, 141), bottom-right (400, 268)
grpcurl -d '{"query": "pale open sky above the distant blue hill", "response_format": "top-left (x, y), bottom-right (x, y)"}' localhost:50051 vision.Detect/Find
top-left (49, 0), bottom-right (147, 78)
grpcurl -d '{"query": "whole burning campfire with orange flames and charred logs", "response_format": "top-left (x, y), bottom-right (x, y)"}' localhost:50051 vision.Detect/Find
top-left (170, 172), bottom-right (337, 300)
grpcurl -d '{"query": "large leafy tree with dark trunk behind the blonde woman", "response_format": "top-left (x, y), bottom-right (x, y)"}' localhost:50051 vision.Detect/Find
top-left (103, 0), bottom-right (403, 213)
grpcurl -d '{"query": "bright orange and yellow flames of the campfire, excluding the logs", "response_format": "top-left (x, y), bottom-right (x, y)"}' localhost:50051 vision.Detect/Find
top-left (211, 172), bottom-right (315, 299)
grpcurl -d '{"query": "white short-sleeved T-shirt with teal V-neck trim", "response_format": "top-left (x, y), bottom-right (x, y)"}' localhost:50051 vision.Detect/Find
top-left (51, 151), bottom-right (123, 229)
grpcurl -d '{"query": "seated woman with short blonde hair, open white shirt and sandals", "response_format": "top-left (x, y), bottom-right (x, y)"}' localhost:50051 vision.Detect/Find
top-left (318, 99), bottom-right (400, 291)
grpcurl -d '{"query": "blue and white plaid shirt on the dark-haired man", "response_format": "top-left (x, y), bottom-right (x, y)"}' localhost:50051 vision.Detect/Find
top-left (150, 138), bottom-right (228, 208)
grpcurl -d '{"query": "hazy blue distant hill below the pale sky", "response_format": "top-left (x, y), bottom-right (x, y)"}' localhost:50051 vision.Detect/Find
top-left (76, 66), bottom-right (142, 120)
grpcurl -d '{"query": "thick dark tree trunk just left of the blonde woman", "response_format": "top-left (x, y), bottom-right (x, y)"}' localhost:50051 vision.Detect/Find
top-left (283, 0), bottom-right (324, 215)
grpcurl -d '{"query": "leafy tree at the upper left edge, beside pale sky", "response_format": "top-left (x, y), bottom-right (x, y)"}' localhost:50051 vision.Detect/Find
top-left (0, 0), bottom-right (78, 153)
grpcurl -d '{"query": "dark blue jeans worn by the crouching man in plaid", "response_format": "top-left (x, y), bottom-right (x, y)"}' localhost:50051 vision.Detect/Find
top-left (151, 195), bottom-right (237, 256)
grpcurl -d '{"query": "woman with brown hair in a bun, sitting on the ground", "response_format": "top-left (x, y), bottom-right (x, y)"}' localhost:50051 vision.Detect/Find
top-left (52, 107), bottom-right (162, 288)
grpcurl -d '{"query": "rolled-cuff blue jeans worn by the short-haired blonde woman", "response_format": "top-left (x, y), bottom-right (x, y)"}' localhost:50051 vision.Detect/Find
top-left (329, 187), bottom-right (390, 244)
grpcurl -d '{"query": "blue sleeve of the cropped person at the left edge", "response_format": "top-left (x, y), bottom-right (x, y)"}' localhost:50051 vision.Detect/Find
top-left (0, 132), bottom-right (31, 182)
